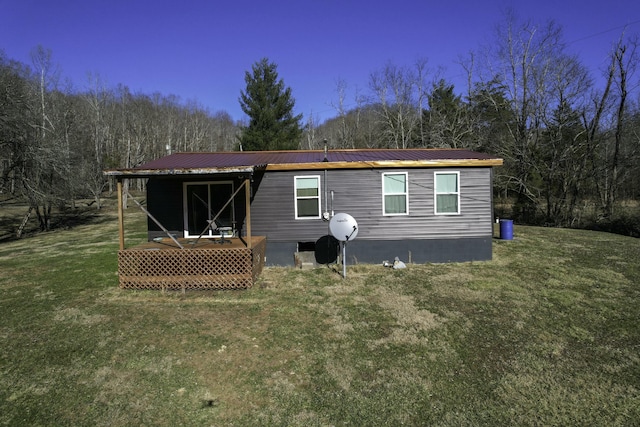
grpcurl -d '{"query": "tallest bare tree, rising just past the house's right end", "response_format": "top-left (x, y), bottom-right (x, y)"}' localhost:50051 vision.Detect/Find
top-left (483, 15), bottom-right (563, 221)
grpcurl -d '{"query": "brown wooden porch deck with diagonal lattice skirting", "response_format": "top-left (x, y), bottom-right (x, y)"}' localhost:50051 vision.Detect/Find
top-left (118, 236), bottom-right (267, 291)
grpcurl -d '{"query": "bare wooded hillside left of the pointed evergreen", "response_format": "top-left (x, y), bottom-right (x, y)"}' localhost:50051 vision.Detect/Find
top-left (0, 47), bottom-right (238, 230)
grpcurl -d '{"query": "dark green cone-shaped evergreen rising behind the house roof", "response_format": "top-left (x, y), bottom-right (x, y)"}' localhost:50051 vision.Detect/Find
top-left (239, 58), bottom-right (302, 151)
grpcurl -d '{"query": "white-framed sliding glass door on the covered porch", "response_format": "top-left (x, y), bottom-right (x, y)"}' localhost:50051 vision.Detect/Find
top-left (184, 181), bottom-right (235, 237)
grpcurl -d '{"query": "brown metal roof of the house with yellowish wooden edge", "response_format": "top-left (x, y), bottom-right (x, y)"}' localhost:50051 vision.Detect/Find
top-left (105, 149), bottom-right (502, 176)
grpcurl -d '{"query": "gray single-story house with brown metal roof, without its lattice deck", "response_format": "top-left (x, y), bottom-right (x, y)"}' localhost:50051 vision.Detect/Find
top-left (105, 149), bottom-right (502, 290)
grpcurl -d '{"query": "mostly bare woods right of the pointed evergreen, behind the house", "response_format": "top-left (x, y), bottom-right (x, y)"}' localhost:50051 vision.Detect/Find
top-left (303, 17), bottom-right (640, 231)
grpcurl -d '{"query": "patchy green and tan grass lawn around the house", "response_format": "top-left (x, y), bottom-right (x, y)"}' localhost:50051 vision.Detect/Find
top-left (0, 199), bottom-right (640, 426)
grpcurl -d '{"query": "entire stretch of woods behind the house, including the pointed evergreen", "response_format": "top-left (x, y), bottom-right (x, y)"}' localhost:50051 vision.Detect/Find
top-left (0, 18), bottom-right (640, 234)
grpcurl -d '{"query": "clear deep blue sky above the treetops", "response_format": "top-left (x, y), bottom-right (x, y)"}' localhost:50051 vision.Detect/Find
top-left (0, 0), bottom-right (640, 120)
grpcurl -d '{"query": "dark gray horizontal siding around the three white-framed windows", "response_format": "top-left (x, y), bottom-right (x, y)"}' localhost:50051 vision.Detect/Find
top-left (251, 168), bottom-right (492, 242)
